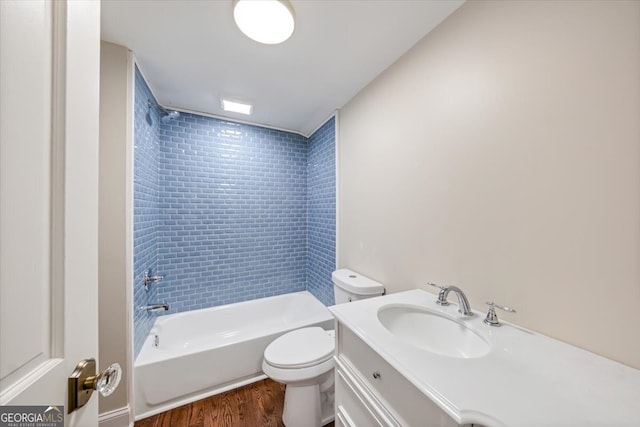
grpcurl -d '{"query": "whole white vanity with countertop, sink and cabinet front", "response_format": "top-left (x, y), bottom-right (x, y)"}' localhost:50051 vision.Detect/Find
top-left (329, 289), bottom-right (640, 427)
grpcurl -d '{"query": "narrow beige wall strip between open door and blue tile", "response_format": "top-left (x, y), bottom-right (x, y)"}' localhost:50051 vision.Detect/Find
top-left (99, 42), bottom-right (133, 424)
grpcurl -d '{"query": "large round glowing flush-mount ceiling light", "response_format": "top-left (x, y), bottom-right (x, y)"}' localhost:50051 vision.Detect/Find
top-left (233, 0), bottom-right (295, 44)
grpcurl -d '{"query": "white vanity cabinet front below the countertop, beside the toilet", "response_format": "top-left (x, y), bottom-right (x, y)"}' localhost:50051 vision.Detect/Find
top-left (335, 322), bottom-right (470, 427)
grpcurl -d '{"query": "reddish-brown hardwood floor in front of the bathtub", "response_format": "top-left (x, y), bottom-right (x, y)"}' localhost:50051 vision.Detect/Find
top-left (134, 379), bottom-right (334, 427)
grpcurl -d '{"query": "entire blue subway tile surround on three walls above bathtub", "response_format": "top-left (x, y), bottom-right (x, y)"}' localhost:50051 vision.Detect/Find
top-left (134, 72), bottom-right (335, 355)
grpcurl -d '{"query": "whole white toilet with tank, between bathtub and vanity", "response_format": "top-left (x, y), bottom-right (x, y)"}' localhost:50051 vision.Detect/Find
top-left (262, 269), bottom-right (384, 427)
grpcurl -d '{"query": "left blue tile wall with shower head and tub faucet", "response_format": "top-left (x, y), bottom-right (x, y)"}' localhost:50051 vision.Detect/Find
top-left (133, 68), bottom-right (160, 357)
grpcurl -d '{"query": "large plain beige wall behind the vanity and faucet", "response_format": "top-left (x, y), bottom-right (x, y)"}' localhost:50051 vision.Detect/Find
top-left (338, 1), bottom-right (640, 368)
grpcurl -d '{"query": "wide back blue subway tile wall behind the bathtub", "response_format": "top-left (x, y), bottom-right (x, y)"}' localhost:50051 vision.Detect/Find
top-left (158, 113), bottom-right (308, 313)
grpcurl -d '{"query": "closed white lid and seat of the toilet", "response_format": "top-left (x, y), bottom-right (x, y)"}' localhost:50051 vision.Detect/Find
top-left (264, 326), bottom-right (335, 369)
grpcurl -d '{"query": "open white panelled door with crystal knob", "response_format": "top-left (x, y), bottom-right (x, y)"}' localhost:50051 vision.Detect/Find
top-left (0, 0), bottom-right (100, 427)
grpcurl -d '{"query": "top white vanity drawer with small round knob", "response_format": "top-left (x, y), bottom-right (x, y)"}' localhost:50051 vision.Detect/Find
top-left (337, 324), bottom-right (459, 427)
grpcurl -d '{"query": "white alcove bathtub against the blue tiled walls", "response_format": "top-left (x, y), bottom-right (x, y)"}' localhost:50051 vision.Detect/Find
top-left (134, 291), bottom-right (333, 420)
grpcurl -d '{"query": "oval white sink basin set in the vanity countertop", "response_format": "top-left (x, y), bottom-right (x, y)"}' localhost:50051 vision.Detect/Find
top-left (378, 304), bottom-right (490, 359)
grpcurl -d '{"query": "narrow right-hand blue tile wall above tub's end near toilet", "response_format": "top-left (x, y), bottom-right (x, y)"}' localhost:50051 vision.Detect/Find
top-left (307, 118), bottom-right (336, 305)
